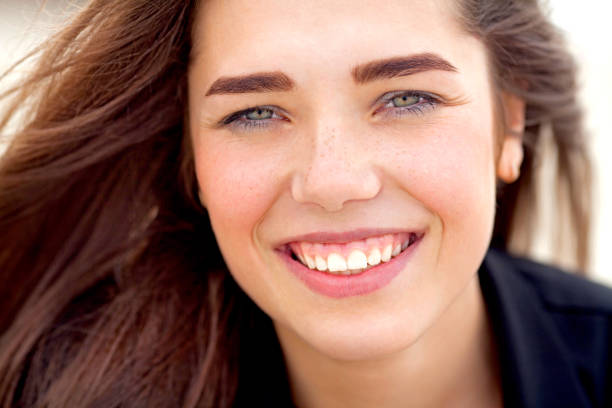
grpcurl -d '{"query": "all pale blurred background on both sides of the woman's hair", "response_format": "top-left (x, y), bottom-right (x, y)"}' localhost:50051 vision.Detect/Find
top-left (0, 0), bottom-right (612, 285)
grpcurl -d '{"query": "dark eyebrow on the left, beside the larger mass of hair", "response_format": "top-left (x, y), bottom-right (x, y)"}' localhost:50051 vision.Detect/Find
top-left (206, 72), bottom-right (294, 96)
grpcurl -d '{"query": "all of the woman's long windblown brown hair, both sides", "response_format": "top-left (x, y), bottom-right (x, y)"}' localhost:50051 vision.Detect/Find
top-left (0, 0), bottom-right (589, 407)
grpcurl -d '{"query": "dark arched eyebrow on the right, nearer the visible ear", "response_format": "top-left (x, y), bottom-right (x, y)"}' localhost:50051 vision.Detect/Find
top-left (351, 53), bottom-right (457, 84)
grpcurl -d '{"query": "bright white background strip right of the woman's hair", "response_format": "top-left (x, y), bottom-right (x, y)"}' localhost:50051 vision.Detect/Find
top-left (550, 0), bottom-right (612, 284)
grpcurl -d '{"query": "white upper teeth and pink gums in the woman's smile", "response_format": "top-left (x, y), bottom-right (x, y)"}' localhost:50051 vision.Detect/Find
top-left (292, 234), bottom-right (415, 275)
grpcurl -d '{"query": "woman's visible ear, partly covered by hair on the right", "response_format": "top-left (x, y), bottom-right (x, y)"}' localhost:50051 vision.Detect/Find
top-left (497, 92), bottom-right (525, 183)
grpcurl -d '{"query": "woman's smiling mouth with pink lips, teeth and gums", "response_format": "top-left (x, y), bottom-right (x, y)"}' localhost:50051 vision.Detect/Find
top-left (276, 231), bottom-right (425, 298)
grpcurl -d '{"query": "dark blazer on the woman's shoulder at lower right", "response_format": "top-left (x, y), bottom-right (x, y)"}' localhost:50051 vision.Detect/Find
top-left (479, 250), bottom-right (612, 408)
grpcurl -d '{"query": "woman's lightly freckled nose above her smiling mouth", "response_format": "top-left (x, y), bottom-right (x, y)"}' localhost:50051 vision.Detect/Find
top-left (291, 121), bottom-right (382, 212)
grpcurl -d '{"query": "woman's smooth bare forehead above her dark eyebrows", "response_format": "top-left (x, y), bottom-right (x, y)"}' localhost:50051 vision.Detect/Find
top-left (194, 0), bottom-right (468, 79)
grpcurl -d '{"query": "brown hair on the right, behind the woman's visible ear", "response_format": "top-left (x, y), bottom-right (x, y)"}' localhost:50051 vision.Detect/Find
top-left (460, 0), bottom-right (592, 273)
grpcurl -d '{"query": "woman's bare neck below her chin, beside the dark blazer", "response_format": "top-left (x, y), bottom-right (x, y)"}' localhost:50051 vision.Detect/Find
top-left (276, 276), bottom-right (501, 408)
